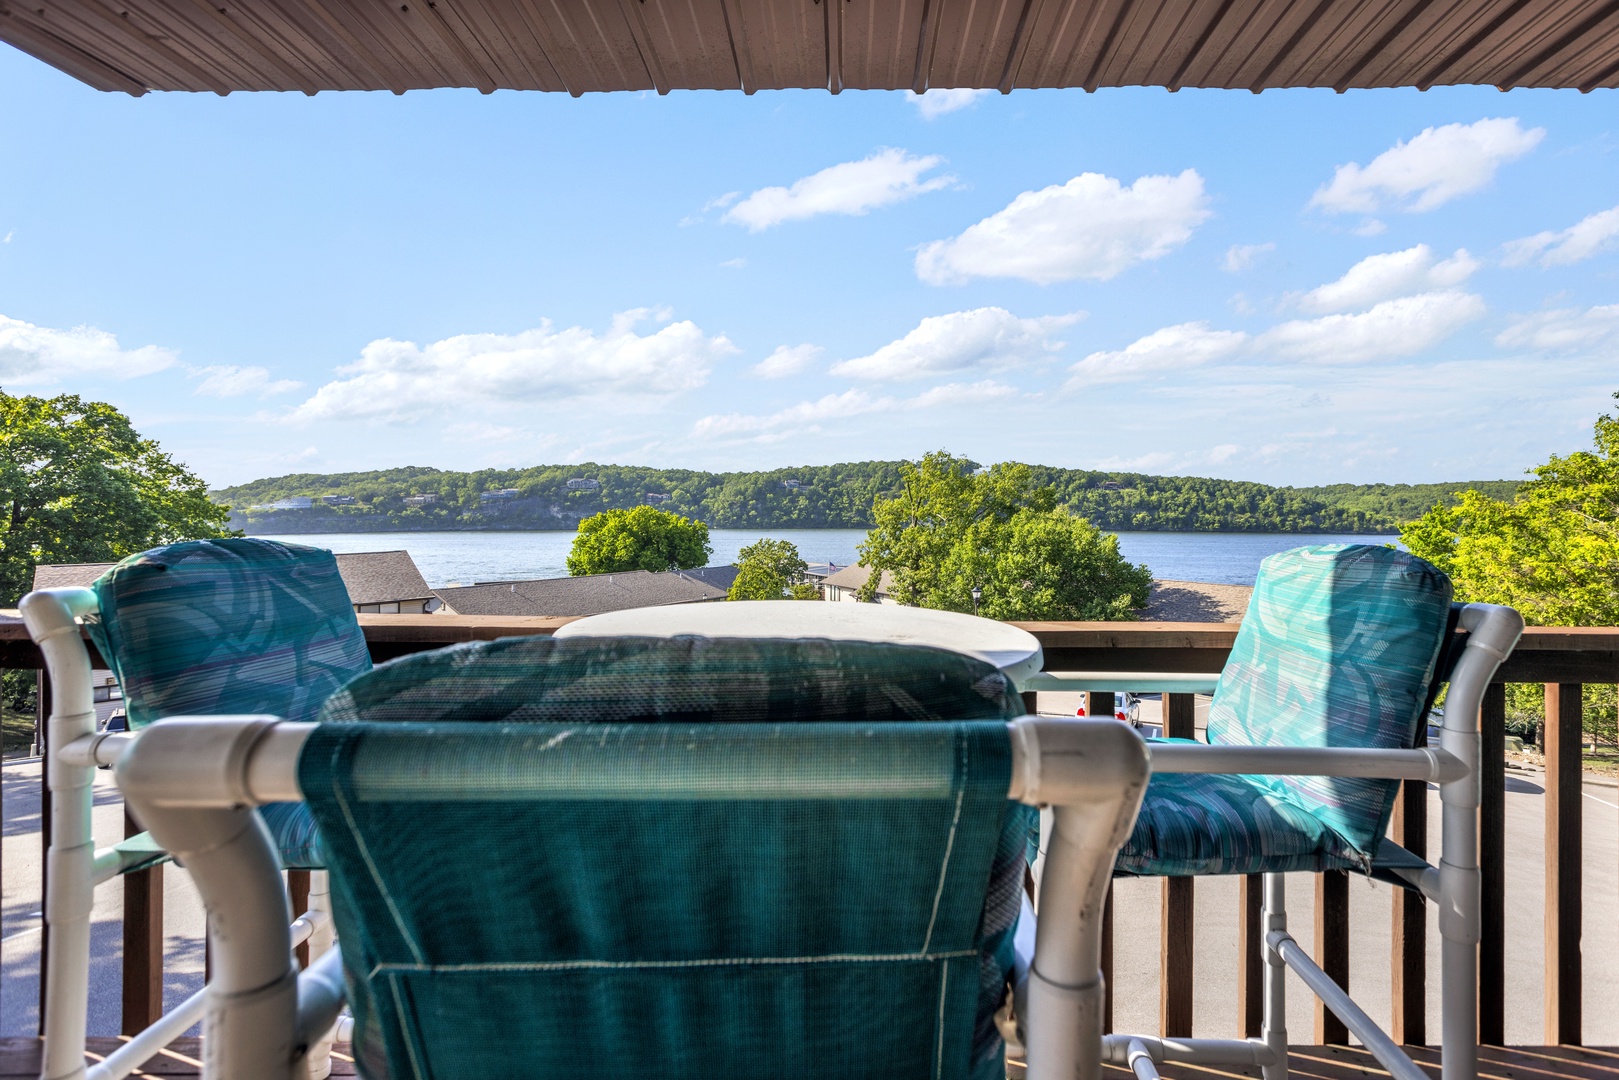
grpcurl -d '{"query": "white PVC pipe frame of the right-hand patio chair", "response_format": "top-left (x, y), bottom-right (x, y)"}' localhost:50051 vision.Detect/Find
top-left (1020, 604), bottom-right (1523, 1080)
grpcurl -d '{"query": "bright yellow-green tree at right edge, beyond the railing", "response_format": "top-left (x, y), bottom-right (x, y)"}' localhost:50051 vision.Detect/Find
top-left (1400, 393), bottom-right (1619, 743)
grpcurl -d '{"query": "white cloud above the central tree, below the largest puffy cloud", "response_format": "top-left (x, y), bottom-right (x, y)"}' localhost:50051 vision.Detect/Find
top-left (832, 308), bottom-right (1085, 379)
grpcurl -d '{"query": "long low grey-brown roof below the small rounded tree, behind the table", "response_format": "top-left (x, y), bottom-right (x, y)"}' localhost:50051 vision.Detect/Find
top-left (437, 570), bottom-right (725, 615)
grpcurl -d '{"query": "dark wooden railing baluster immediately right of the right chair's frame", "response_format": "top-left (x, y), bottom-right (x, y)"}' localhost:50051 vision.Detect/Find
top-left (1478, 683), bottom-right (1507, 1046)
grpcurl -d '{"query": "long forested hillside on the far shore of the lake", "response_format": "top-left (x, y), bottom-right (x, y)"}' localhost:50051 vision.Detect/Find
top-left (212, 461), bottom-right (1517, 534)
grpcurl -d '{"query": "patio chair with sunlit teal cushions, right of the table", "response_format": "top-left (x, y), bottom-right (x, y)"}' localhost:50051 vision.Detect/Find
top-left (1010, 544), bottom-right (1523, 1080)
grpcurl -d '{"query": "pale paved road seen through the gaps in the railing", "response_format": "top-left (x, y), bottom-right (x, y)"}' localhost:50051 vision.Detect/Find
top-left (0, 735), bottom-right (1619, 1046)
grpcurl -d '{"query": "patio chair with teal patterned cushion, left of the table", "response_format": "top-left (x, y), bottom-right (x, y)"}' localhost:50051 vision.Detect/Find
top-left (21, 538), bottom-right (371, 1080)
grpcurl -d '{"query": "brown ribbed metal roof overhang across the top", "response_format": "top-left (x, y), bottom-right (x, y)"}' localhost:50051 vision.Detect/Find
top-left (0, 0), bottom-right (1619, 94)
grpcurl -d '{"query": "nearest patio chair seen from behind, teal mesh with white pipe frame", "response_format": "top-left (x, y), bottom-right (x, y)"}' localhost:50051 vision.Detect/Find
top-left (117, 636), bottom-right (1146, 1080)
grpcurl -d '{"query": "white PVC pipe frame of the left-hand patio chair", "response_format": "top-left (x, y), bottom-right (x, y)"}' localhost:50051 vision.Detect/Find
top-left (19, 589), bottom-right (334, 1080)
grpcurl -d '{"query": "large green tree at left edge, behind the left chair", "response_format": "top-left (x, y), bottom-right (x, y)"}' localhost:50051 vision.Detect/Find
top-left (0, 392), bottom-right (232, 607)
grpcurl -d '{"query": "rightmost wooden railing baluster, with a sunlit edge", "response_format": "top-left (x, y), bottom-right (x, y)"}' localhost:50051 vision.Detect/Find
top-left (1545, 683), bottom-right (1583, 1046)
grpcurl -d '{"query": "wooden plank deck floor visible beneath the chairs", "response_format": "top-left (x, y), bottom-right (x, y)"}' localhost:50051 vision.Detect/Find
top-left (0, 1038), bottom-right (1619, 1080)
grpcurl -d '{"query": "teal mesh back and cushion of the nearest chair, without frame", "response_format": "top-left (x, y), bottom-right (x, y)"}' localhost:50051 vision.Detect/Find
top-left (300, 638), bottom-right (1031, 1080)
